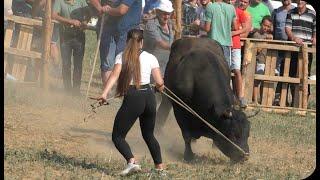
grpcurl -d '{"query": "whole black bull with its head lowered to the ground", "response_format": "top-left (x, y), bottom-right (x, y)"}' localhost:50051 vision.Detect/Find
top-left (164, 38), bottom-right (250, 162)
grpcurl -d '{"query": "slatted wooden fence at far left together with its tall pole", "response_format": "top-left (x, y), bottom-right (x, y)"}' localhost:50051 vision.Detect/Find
top-left (4, 1), bottom-right (53, 90)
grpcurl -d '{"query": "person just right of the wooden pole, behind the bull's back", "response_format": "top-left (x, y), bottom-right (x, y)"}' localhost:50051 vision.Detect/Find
top-left (182, 0), bottom-right (200, 36)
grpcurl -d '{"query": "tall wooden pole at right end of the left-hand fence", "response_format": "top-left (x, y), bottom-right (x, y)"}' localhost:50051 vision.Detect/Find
top-left (40, 0), bottom-right (52, 90)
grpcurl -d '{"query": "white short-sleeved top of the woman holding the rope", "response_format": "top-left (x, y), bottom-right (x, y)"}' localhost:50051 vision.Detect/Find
top-left (115, 51), bottom-right (159, 85)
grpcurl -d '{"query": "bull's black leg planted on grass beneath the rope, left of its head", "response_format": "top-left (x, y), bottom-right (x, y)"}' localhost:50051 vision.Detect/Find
top-left (173, 104), bottom-right (194, 161)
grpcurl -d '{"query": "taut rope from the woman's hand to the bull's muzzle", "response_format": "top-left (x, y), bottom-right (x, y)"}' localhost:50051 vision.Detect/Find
top-left (153, 85), bottom-right (247, 155)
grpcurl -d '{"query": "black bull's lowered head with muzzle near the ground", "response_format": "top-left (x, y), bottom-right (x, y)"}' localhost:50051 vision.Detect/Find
top-left (214, 110), bottom-right (250, 162)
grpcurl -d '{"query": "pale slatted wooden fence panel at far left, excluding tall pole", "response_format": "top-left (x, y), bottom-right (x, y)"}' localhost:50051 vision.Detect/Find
top-left (4, 15), bottom-right (53, 86)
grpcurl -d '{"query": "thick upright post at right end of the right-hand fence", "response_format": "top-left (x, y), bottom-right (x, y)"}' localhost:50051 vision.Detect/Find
top-left (302, 43), bottom-right (309, 109)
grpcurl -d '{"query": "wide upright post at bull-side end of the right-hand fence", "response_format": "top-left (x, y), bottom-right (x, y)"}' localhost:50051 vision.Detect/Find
top-left (242, 39), bottom-right (257, 102)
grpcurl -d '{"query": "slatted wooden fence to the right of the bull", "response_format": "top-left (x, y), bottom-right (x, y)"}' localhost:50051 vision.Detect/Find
top-left (241, 38), bottom-right (316, 112)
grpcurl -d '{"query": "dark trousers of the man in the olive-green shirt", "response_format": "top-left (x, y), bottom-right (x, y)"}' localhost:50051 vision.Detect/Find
top-left (60, 32), bottom-right (85, 93)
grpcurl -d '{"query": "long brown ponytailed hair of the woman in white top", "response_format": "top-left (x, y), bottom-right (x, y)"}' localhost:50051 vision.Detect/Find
top-left (117, 29), bottom-right (143, 96)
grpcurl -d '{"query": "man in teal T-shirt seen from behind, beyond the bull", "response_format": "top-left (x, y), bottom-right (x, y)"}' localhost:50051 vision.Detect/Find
top-left (205, 0), bottom-right (236, 67)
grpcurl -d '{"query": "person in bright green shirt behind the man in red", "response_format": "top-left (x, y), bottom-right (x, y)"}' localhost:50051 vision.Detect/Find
top-left (247, 0), bottom-right (271, 33)
